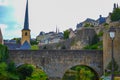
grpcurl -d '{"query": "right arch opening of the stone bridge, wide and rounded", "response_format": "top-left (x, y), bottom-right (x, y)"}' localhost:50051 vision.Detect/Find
top-left (62, 65), bottom-right (99, 80)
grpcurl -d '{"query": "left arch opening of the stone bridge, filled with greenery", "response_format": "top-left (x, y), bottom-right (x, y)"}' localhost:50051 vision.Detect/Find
top-left (16, 63), bottom-right (49, 80)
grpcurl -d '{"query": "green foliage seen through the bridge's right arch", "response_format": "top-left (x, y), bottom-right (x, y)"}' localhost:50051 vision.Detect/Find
top-left (62, 66), bottom-right (98, 80)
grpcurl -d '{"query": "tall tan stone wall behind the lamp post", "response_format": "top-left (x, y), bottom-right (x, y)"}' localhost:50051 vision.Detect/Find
top-left (103, 22), bottom-right (120, 70)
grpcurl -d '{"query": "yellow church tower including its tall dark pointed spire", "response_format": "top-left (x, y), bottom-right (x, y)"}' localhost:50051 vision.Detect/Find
top-left (21, 0), bottom-right (31, 45)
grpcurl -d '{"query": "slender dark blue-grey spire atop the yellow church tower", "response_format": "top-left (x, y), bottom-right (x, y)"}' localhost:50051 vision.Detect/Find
top-left (23, 0), bottom-right (29, 30)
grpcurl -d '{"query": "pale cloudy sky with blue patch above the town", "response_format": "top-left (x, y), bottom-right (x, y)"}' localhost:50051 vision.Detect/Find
top-left (0, 0), bottom-right (120, 39)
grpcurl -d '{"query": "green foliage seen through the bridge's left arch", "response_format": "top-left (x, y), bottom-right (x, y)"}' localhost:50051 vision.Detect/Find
top-left (17, 64), bottom-right (48, 80)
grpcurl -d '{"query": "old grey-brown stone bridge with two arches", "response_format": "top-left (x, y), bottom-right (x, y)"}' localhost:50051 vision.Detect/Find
top-left (9, 50), bottom-right (103, 80)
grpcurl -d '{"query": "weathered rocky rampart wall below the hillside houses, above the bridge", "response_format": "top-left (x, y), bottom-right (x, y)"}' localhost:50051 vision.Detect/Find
top-left (40, 28), bottom-right (96, 50)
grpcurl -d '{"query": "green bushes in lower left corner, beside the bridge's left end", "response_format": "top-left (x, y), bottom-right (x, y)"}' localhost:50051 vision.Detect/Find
top-left (0, 45), bottom-right (19, 80)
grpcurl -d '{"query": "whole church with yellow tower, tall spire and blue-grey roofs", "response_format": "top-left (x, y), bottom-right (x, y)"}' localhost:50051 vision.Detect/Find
top-left (3, 0), bottom-right (31, 50)
